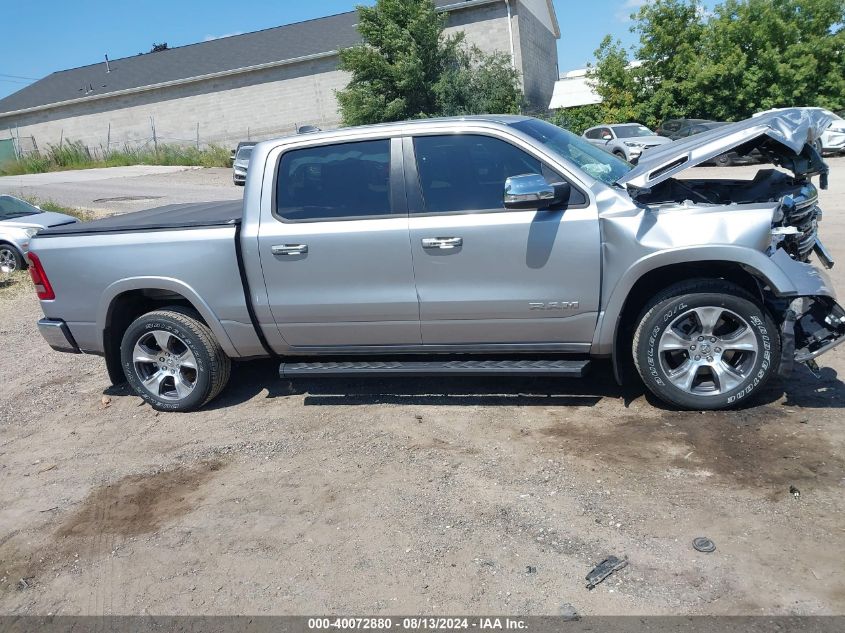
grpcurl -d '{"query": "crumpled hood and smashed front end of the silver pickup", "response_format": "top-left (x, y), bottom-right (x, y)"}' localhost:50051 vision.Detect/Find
top-left (619, 108), bottom-right (845, 376)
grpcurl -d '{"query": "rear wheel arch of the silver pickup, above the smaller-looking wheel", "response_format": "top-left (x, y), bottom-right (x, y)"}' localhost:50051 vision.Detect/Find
top-left (97, 278), bottom-right (239, 384)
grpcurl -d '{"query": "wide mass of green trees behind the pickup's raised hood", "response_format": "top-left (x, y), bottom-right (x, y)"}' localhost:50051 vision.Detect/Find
top-left (590, 0), bottom-right (845, 125)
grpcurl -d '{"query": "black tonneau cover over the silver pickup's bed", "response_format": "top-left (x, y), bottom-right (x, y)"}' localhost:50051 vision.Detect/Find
top-left (38, 200), bottom-right (243, 237)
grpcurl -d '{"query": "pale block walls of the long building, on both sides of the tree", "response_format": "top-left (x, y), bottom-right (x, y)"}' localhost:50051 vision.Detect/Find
top-left (0, 2), bottom-right (557, 151)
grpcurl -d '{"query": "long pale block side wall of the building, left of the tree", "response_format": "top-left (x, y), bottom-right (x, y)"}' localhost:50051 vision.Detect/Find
top-left (0, 56), bottom-right (348, 150)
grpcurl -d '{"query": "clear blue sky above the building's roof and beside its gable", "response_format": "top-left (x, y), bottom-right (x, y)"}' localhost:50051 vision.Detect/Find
top-left (0, 0), bottom-right (664, 98)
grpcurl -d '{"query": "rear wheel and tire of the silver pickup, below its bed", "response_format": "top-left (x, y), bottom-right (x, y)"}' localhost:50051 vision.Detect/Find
top-left (120, 306), bottom-right (232, 411)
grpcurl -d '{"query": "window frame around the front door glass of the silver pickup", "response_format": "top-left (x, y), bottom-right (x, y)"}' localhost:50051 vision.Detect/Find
top-left (402, 130), bottom-right (592, 218)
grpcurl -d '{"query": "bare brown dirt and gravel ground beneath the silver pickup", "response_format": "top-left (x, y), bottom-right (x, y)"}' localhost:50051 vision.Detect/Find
top-left (0, 159), bottom-right (845, 615)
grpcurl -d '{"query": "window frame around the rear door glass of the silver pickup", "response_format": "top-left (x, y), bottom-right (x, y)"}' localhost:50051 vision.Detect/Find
top-left (270, 135), bottom-right (408, 224)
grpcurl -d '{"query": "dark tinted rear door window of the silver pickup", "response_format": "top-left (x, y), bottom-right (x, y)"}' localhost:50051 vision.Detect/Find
top-left (276, 139), bottom-right (392, 222)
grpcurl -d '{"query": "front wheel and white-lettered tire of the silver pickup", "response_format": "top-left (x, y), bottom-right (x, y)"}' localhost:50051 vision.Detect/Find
top-left (632, 279), bottom-right (780, 410)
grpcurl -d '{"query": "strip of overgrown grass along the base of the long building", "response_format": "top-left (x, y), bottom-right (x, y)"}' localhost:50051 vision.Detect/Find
top-left (0, 141), bottom-right (229, 176)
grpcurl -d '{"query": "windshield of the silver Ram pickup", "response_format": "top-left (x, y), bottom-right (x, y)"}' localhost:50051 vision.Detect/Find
top-left (512, 119), bottom-right (632, 185)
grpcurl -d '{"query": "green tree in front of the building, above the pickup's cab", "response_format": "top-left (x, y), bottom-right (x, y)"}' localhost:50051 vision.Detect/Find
top-left (337, 0), bottom-right (523, 125)
